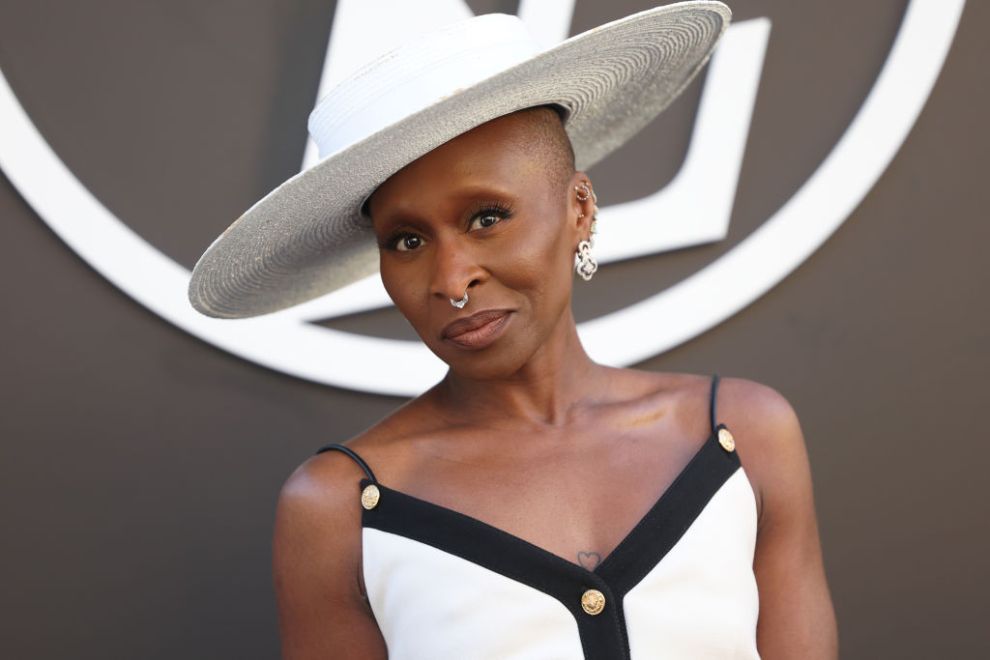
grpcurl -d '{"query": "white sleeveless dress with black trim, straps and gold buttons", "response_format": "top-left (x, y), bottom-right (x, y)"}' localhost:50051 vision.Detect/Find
top-left (317, 374), bottom-right (759, 660)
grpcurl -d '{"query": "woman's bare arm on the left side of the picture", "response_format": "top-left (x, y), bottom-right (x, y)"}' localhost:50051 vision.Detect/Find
top-left (272, 452), bottom-right (387, 660)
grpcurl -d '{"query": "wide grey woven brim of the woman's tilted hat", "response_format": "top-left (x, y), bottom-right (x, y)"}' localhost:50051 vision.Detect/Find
top-left (188, 1), bottom-right (731, 318)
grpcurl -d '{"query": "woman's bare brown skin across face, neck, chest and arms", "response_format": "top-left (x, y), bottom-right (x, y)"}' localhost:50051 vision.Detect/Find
top-left (273, 105), bottom-right (838, 660)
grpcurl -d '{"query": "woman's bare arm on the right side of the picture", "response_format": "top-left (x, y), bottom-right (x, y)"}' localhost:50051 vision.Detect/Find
top-left (726, 379), bottom-right (838, 660)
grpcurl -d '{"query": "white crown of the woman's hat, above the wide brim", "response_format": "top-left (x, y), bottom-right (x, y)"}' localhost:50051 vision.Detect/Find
top-left (308, 14), bottom-right (540, 159)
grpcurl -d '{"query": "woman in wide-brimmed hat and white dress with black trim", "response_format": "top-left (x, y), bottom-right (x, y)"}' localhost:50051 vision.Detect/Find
top-left (190, 2), bottom-right (837, 660)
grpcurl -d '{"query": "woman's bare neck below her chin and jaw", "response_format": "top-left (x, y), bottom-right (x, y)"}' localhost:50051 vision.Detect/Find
top-left (436, 308), bottom-right (603, 427)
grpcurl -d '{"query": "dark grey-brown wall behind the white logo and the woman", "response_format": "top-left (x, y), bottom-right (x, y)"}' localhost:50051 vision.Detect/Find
top-left (0, 0), bottom-right (990, 659)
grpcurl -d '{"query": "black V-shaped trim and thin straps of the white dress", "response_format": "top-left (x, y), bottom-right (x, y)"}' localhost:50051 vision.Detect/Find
top-left (317, 374), bottom-right (741, 660)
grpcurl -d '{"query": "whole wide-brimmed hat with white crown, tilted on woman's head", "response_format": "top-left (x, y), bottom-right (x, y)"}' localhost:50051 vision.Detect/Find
top-left (189, 0), bottom-right (731, 318)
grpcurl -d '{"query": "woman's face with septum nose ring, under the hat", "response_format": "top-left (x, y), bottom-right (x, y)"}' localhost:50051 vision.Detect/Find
top-left (368, 109), bottom-right (592, 379)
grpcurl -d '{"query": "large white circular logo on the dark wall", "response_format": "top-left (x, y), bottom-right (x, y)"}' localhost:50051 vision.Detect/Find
top-left (0, 0), bottom-right (965, 395)
